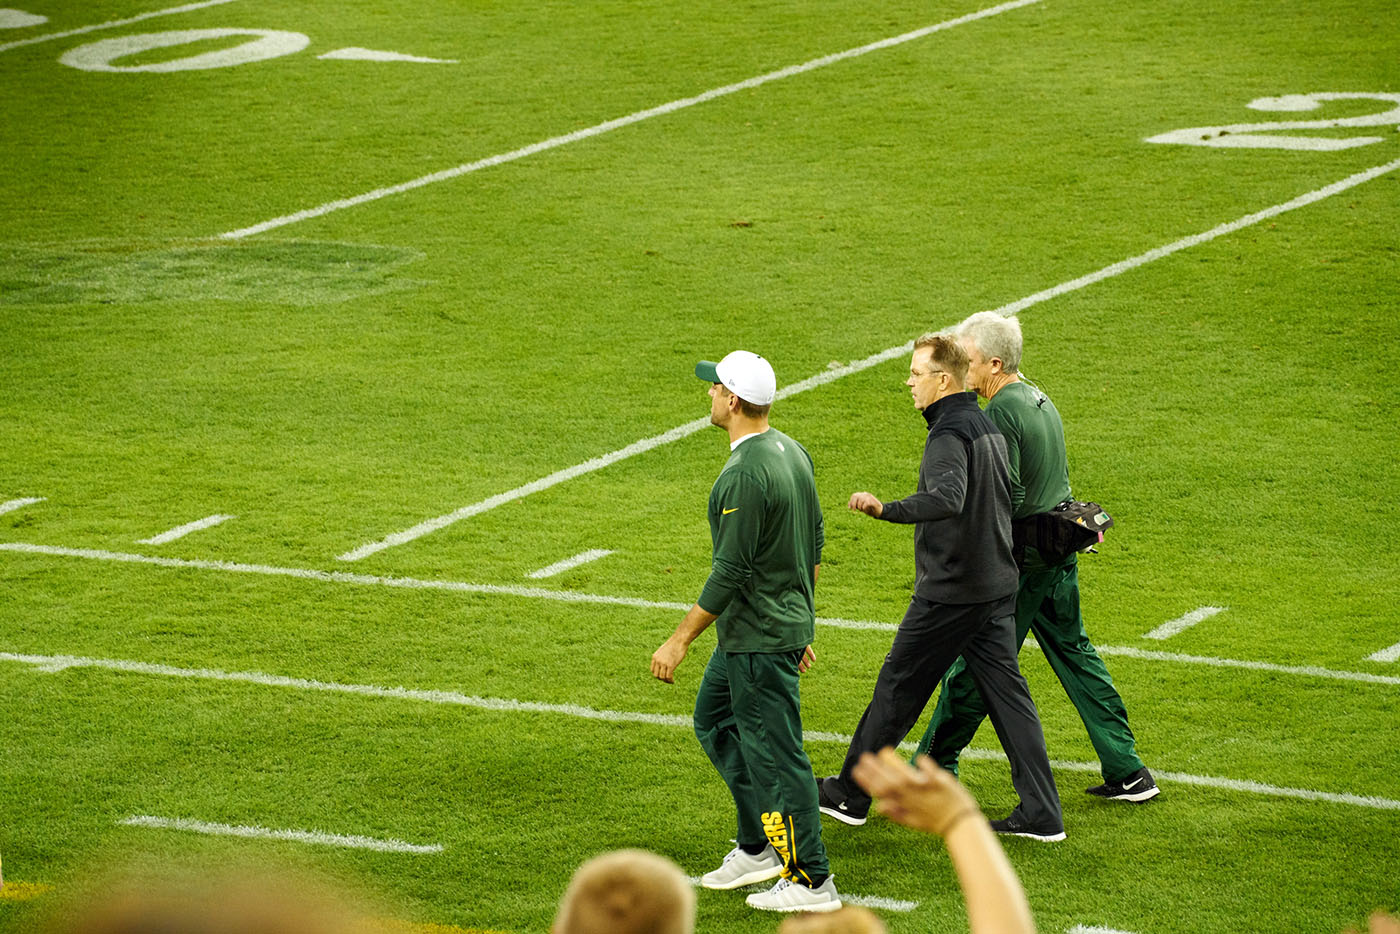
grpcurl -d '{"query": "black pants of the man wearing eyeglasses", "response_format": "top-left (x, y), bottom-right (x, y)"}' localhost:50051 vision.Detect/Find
top-left (830, 594), bottom-right (1064, 828)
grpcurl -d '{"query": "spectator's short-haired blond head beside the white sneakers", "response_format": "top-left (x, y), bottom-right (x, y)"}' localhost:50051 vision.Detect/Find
top-left (550, 850), bottom-right (696, 934)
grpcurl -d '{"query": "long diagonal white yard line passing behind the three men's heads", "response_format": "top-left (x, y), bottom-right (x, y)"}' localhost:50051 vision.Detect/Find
top-left (337, 160), bottom-right (1400, 562)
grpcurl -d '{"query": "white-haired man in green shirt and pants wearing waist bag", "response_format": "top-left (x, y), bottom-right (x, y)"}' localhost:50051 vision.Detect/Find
top-left (918, 311), bottom-right (1159, 802)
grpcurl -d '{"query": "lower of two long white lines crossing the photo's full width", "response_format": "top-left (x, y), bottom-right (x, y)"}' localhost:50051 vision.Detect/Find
top-left (0, 653), bottom-right (1400, 811)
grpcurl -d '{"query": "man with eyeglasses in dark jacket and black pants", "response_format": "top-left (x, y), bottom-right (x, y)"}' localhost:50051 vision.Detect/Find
top-left (818, 335), bottom-right (1064, 842)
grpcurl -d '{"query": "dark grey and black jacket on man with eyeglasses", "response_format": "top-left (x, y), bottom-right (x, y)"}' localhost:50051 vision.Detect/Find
top-left (881, 392), bottom-right (1018, 604)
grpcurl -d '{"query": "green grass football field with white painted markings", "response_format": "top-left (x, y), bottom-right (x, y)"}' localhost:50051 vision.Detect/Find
top-left (0, 0), bottom-right (1400, 934)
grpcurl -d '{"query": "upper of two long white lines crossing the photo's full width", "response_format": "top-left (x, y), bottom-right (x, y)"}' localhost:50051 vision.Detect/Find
top-left (0, 542), bottom-right (1400, 685)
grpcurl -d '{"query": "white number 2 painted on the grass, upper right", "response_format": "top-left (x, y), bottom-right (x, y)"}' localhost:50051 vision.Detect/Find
top-left (1147, 91), bottom-right (1400, 153)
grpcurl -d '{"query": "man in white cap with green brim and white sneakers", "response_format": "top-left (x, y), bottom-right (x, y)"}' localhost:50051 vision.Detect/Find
top-left (651, 350), bottom-right (841, 912)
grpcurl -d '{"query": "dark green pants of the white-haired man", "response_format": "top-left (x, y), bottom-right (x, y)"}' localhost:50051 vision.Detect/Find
top-left (918, 559), bottom-right (1142, 781)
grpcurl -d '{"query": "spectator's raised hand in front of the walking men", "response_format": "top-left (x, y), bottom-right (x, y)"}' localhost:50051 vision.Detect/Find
top-left (853, 746), bottom-right (981, 836)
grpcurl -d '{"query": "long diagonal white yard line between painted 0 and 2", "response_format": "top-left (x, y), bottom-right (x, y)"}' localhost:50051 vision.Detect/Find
top-left (218, 0), bottom-right (1040, 239)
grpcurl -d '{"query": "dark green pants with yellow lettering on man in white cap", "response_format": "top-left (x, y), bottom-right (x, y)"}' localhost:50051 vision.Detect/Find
top-left (694, 648), bottom-right (830, 885)
